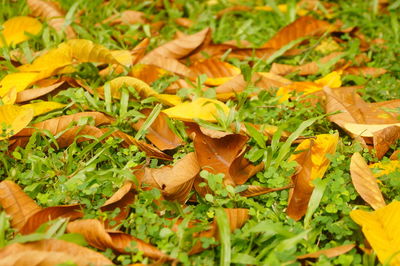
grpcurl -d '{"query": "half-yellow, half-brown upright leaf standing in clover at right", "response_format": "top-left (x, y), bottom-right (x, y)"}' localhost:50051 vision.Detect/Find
top-left (286, 134), bottom-right (339, 221)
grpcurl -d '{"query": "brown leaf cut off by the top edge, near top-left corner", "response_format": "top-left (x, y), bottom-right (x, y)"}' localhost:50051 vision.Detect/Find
top-left (27, 0), bottom-right (76, 39)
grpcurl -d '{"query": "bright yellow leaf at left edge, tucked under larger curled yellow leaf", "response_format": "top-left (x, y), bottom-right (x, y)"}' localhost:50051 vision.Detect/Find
top-left (0, 72), bottom-right (39, 97)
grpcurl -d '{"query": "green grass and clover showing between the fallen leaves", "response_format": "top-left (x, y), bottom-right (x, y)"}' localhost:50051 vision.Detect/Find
top-left (0, 0), bottom-right (400, 265)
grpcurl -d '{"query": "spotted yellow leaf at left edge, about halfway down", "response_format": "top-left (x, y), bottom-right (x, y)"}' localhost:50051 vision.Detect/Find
top-left (0, 104), bottom-right (33, 140)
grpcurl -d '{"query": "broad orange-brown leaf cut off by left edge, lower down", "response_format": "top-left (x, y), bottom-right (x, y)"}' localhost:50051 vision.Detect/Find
top-left (0, 180), bottom-right (41, 230)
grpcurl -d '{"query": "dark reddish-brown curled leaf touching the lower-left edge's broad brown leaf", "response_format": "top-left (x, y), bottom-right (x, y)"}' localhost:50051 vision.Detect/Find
top-left (20, 204), bottom-right (83, 235)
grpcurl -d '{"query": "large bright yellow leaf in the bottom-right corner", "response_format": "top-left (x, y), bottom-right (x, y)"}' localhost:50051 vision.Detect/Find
top-left (350, 201), bottom-right (400, 265)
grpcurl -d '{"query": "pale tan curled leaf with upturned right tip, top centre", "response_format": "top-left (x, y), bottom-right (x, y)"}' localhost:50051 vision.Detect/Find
top-left (140, 28), bottom-right (210, 63)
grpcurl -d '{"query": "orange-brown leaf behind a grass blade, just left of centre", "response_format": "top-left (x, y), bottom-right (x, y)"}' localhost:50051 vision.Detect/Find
top-left (132, 109), bottom-right (183, 150)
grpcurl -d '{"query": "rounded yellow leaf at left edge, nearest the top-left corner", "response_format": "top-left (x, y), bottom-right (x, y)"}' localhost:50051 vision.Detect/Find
top-left (0, 16), bottom-right (42, 48)
